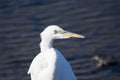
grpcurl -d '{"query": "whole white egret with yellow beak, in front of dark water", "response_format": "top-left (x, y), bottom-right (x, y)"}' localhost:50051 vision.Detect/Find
top-left (28, 25), bottom-right (85, 80)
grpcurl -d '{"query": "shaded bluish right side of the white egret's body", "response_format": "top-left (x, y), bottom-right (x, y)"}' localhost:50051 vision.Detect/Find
top-left (53, 50), bottom-right (77, 80)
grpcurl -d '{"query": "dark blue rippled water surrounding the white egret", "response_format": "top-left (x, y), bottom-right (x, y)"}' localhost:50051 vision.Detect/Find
top-left (0, 0), bottom-right (120, 80)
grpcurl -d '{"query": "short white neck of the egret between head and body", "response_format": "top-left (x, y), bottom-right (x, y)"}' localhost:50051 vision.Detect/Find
top-left (40, 37), bottom-right (53, 52)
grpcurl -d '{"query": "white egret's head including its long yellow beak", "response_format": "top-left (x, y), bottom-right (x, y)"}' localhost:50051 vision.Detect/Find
top-left (41, 25), bottom-right (85, 39)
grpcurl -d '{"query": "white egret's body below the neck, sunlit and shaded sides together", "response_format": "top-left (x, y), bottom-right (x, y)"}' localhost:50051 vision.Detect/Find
top-left (28, 48), bottom-right (77, 80)
